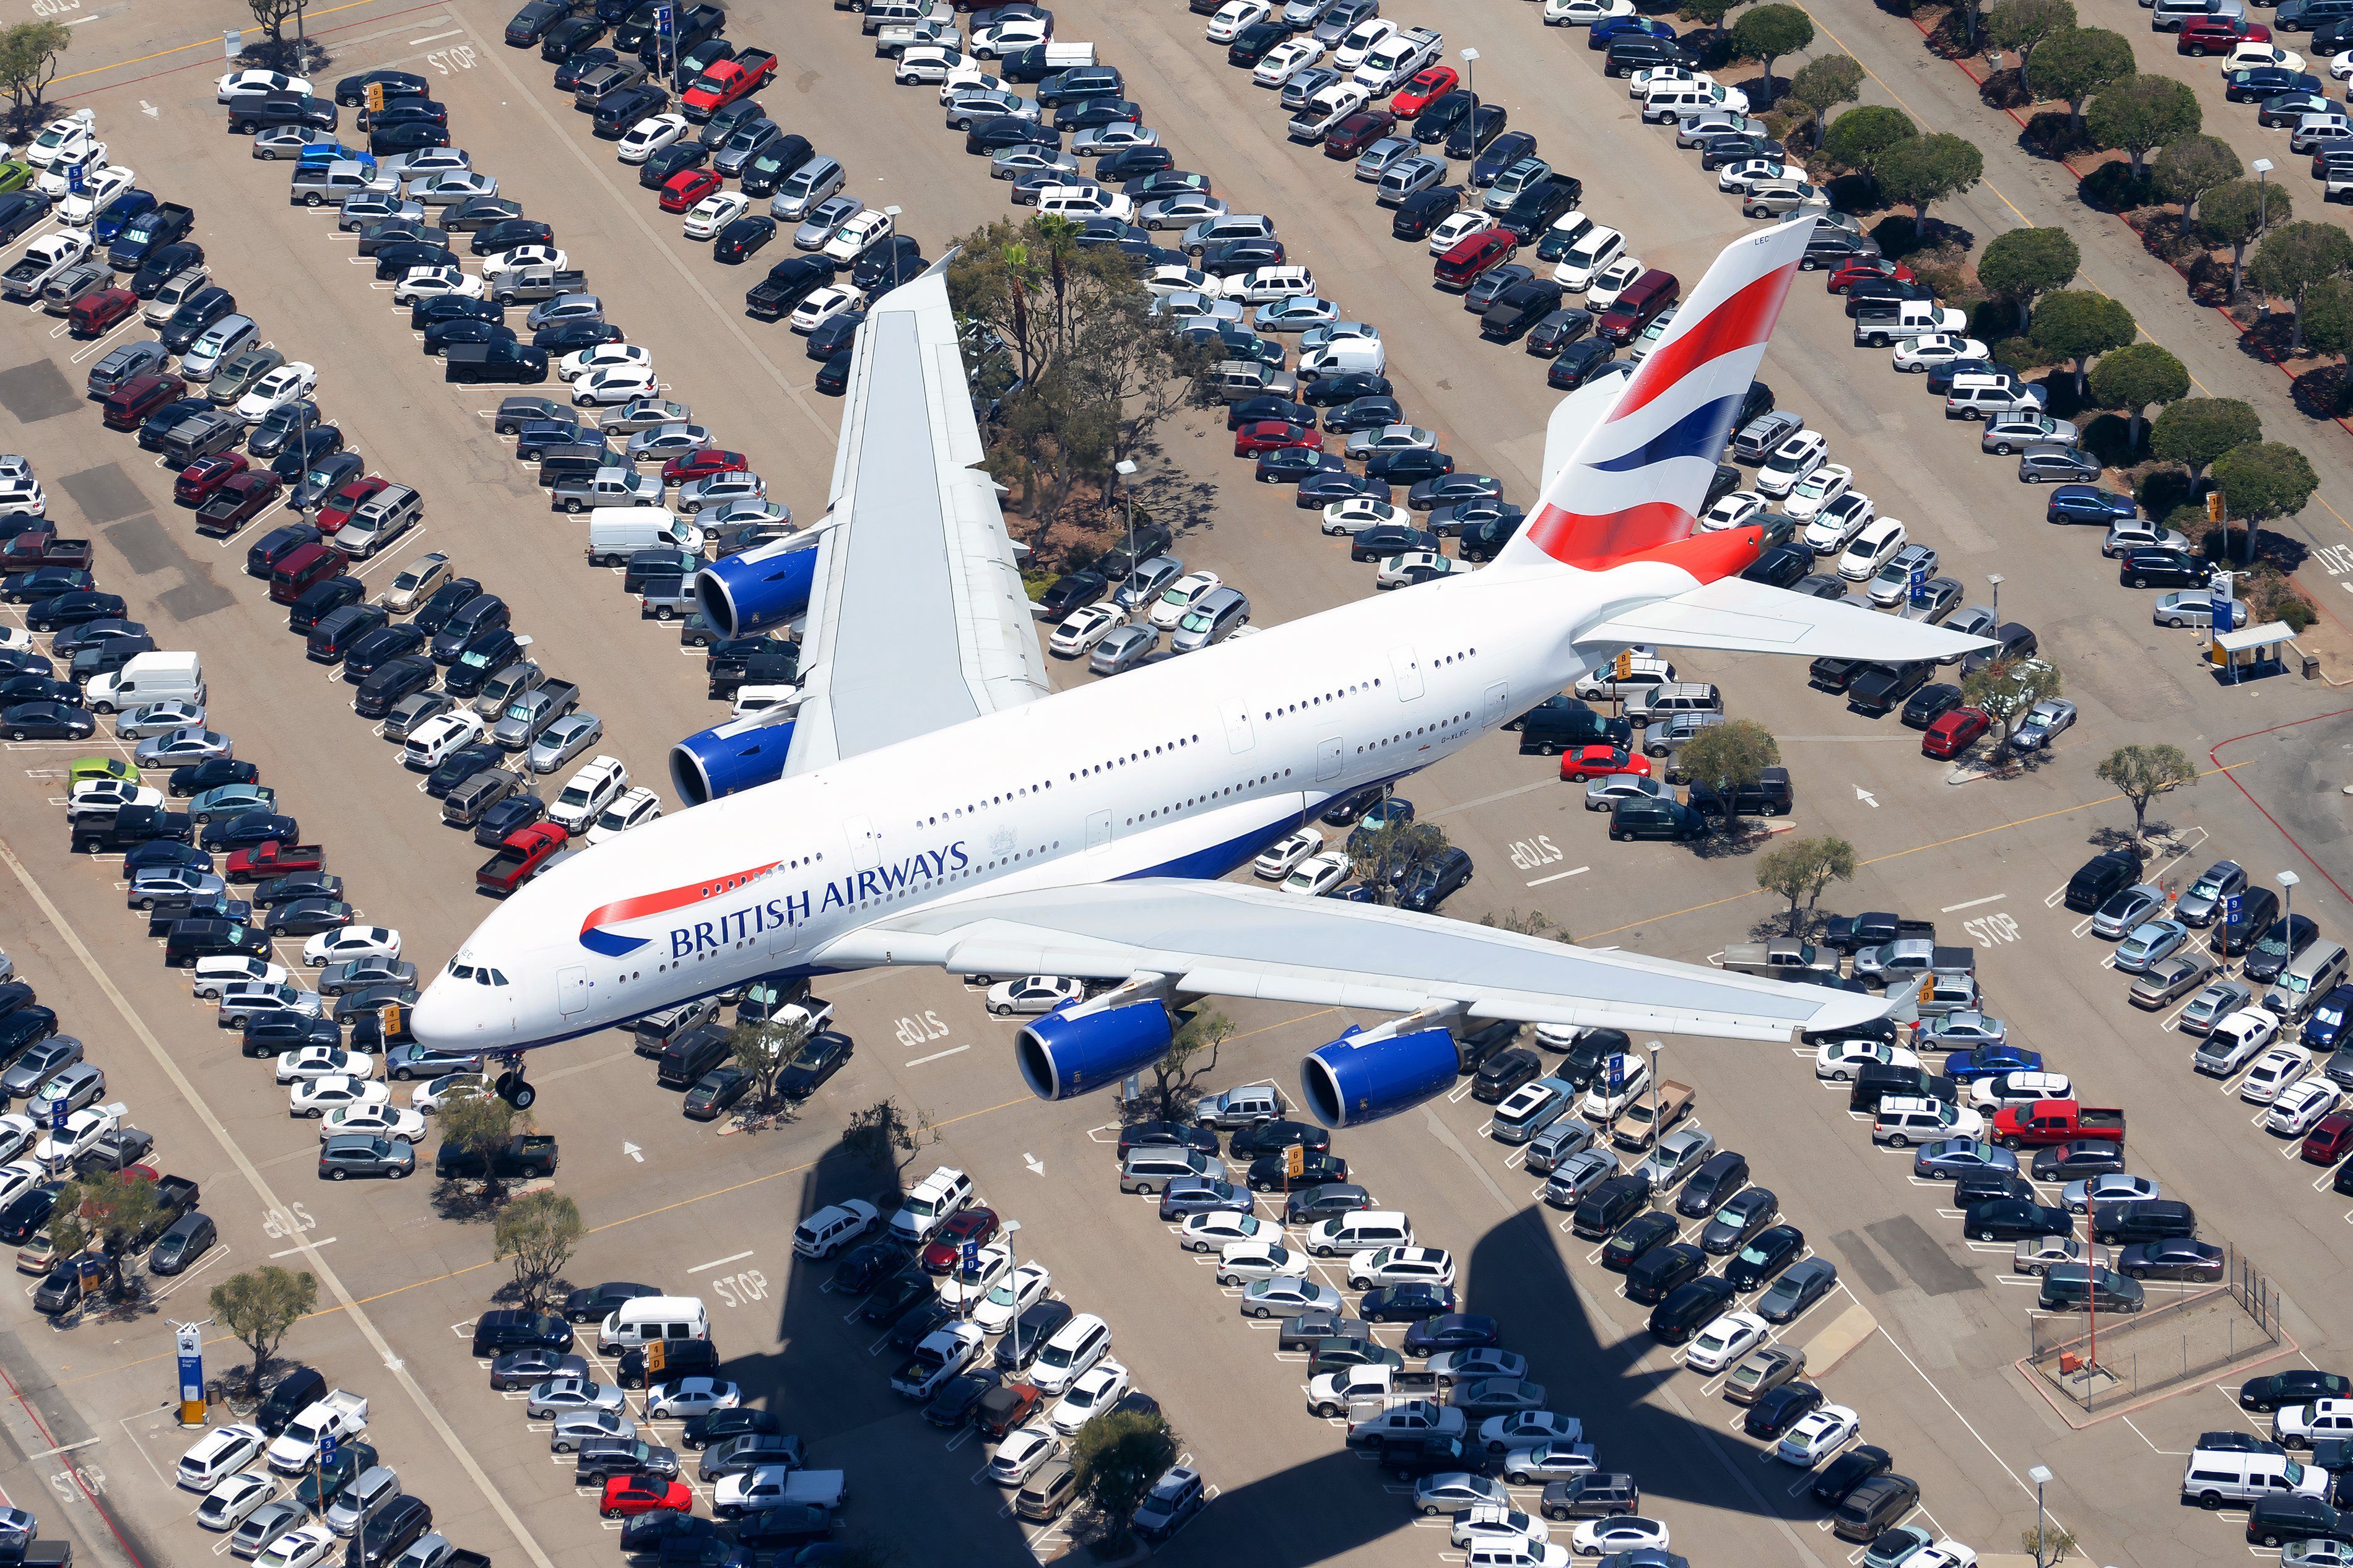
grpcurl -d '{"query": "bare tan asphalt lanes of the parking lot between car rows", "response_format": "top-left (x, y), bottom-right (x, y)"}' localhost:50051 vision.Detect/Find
top-left (0, 0), bottom-right (2353, 1568)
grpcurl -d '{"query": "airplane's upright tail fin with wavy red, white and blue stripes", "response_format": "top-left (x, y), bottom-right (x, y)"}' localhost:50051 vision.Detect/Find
top-left (1497, 216), bottom-right (1814, 583)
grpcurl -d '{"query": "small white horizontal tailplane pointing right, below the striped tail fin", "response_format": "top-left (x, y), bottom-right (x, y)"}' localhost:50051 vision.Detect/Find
top-left (1577, 578), bottom-right (1993, 665)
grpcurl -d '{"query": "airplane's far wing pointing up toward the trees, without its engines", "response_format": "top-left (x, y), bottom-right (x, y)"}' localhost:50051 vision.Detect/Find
top-left (783, 268), bottom-right (1047, 773)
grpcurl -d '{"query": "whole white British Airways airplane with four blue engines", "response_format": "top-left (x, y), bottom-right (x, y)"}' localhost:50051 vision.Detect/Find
top-left (414, 219), bottom-right (1983, 1126)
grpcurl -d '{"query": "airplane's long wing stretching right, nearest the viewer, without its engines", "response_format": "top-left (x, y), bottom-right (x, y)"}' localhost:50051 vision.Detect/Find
top-left (814, 877), bottom-right (1889, 1039)
